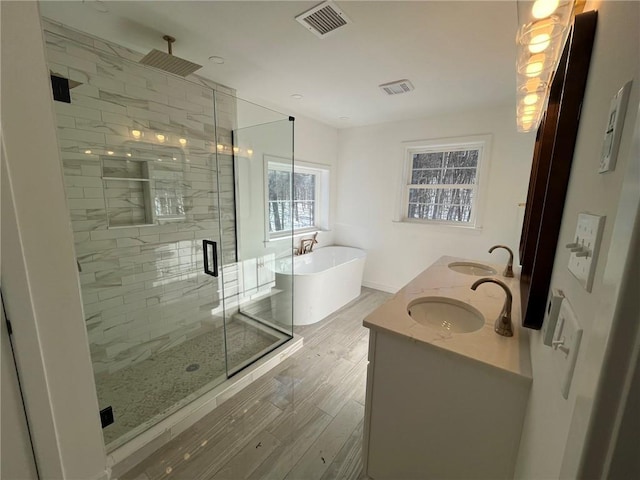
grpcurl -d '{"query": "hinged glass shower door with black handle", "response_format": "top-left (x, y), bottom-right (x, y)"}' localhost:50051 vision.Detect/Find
top-left (45, 32), bottom-right (233, 451)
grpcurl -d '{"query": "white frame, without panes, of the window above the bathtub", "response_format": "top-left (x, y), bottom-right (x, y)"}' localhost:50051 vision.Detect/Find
top-left (264, 155), bottom-right (331, 240)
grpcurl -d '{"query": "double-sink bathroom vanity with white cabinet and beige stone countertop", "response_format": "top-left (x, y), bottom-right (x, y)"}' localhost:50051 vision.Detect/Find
top-left (363, 257), bottom-right (532, 480)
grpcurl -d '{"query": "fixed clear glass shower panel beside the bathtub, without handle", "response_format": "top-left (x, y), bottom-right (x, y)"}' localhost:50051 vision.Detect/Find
top-left (215, 92), bottom-right (294, 376)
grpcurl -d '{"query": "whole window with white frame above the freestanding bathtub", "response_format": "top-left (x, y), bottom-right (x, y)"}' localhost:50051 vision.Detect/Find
top-left (267, 161), bottom-right (329, 238)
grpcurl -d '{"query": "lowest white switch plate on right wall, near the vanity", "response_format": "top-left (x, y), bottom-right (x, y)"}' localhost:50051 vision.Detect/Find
top-left (551, 298), bottom-right (582, 398)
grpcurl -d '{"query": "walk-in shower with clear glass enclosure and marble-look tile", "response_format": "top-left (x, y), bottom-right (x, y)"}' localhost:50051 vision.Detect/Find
top-left (45, 23), bottom-right (294, 450)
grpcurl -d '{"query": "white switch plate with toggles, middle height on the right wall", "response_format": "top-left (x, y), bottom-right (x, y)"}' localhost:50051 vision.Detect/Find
top-left (566, 213), bottom-right (605, 292)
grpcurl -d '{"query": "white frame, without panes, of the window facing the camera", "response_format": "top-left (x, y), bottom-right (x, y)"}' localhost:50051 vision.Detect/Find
top-left (395, 135), bottom-right (492, 229)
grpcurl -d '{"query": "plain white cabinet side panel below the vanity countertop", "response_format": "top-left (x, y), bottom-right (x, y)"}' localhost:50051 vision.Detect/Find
top-left (364, 331), bottom-right (531, 480)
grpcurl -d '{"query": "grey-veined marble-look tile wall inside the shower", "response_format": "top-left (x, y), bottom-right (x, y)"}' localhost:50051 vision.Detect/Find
top-left (44, 20), bottom-right (237, 374)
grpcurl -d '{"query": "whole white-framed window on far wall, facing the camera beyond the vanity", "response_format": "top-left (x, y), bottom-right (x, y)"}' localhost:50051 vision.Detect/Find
top-left (402, 135), bottom-right (487, 227)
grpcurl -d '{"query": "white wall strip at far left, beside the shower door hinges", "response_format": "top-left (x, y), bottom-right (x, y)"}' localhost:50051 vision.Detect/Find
top-left (1, 2), bottom-right (106, 479)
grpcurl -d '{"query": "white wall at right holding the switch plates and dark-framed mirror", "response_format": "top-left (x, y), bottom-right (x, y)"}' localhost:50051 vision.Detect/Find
top-left (516, 2), bottom-right (640, 479)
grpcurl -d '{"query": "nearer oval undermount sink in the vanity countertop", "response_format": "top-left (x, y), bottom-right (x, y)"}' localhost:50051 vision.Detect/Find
top-left (407, 297), bottom-right (484, 333)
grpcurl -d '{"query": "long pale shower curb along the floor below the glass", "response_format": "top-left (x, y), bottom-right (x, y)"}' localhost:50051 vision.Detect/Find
top-left (107, 334), bottom-right (304, 480)
